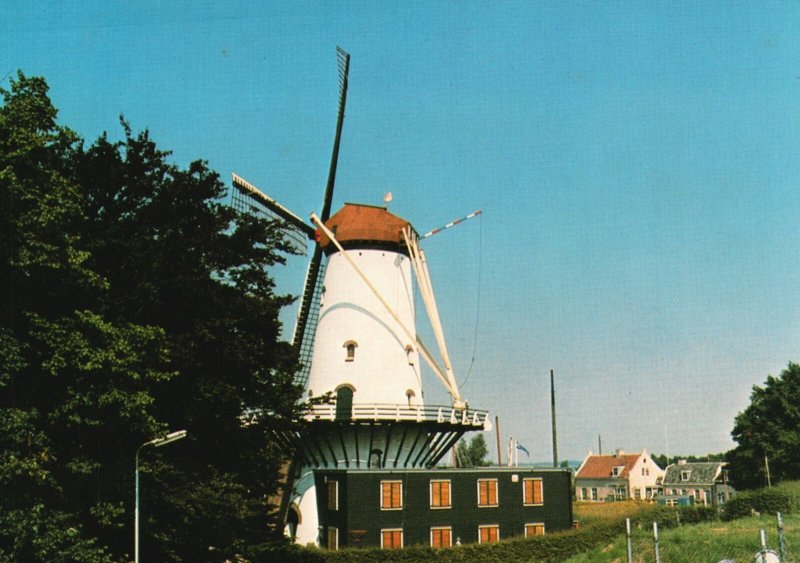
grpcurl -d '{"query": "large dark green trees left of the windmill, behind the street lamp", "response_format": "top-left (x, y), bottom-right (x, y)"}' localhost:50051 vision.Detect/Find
top-left (0, 73), bottom-right (299, 561)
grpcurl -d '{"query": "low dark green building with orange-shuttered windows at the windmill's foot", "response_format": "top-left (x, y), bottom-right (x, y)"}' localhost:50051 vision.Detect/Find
top-left (314, 467), bottom-right (572, 549)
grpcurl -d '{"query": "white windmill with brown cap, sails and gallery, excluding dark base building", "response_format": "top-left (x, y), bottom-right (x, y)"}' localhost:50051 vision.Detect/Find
top-left (228, 49), bottom-right (488, 543)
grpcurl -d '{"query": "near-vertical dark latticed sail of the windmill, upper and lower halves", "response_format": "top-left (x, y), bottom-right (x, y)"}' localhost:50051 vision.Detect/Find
top-left (292, 47), bottom-right (350, 386)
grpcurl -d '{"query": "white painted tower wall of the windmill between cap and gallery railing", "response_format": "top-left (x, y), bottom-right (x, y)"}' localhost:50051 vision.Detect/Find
top-left (308, 249), bottom-right (423, 406)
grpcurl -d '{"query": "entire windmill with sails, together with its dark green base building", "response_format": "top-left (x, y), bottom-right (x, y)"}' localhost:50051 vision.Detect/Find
top-left (234, 50), bottom-right (572, 549)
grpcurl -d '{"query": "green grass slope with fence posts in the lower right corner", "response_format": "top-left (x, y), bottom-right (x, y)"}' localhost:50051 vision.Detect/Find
top-left (567, 514), bottom-right (800, 563)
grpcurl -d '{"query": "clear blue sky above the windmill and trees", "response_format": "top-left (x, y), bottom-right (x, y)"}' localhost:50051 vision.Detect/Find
top-left (6, 1), bottom-right (800, 460)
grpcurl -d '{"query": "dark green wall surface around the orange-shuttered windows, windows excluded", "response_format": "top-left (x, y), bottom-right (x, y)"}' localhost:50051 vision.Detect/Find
top-left (315, 467), bottom-right (572, 547)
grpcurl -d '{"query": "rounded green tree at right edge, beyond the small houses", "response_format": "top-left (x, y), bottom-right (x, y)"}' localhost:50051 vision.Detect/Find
top-left (727, 363), bottom-right (800, 489)
